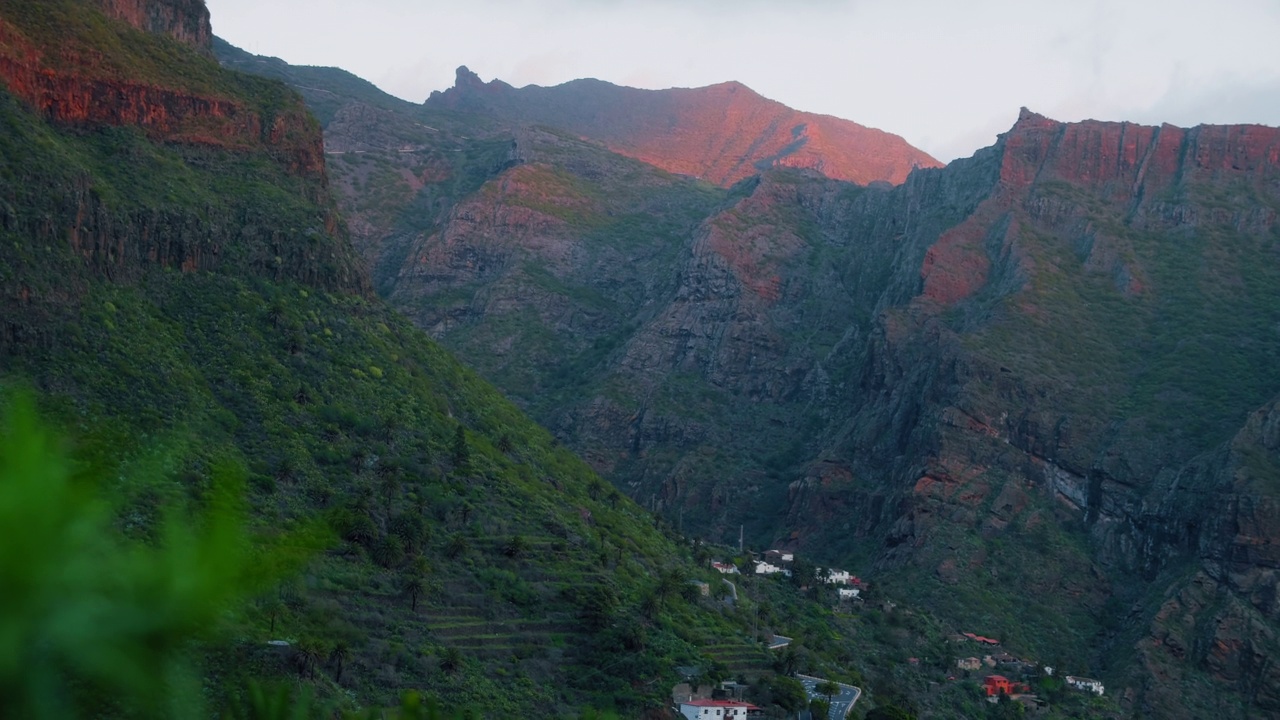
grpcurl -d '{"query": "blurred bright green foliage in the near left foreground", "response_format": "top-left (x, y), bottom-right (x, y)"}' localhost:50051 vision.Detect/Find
top-left (0, 395), bottom-right (252, 719)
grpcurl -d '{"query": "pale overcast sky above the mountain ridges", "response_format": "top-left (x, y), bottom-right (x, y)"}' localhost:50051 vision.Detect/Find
top-left (207, 0), bottom-right (1280, 161)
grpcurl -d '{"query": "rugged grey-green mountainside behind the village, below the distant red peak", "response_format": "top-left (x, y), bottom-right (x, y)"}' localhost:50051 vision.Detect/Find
top-left (225, 39), bottom-right (1280, 717)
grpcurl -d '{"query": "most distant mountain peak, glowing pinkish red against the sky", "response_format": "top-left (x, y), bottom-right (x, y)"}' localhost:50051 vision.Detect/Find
top-left (426, 67), bottom-right (940, 186)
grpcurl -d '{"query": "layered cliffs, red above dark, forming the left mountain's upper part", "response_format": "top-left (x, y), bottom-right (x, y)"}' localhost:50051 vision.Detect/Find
top-left (0, 0), bottom-right (369, 327)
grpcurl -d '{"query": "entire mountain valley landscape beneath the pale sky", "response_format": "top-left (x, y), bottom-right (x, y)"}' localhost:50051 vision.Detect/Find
top-left (0, 0), bottom-right (1280, 719)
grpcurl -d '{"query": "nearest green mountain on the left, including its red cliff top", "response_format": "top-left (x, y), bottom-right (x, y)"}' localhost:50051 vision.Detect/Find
top-left (0, 0), bottom-right (938, 717)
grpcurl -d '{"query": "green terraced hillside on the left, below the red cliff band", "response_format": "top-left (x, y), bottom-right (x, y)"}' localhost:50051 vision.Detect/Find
top-left (0, 5), bottom-right (768, 716)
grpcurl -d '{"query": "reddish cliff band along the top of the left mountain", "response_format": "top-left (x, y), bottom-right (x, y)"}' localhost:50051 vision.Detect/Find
top-left (0, 0), bottom-right (325, 183)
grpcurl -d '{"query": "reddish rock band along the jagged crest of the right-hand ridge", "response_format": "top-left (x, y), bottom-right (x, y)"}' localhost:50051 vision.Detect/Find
top-left (920, 108), bottom-right (1280, 305)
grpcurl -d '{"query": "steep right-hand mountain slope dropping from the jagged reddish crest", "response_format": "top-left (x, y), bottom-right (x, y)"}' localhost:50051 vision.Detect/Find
top-left (788, 111), bottom-right (1280, 716)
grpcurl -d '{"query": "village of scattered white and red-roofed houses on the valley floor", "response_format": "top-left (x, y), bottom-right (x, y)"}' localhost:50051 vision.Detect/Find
top-left (671, 550), bottom-right (1106, 720)
